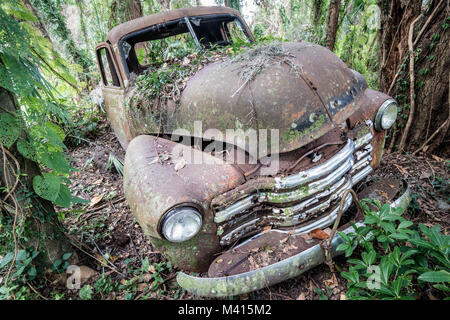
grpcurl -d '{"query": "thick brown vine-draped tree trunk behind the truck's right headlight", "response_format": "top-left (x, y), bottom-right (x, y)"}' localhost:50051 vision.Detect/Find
top-left (378, 0), bottom-right (450, 157)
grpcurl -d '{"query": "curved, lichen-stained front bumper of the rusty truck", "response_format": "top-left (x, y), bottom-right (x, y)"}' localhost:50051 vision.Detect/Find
top-left (177, 182), bottom-right (411, 297)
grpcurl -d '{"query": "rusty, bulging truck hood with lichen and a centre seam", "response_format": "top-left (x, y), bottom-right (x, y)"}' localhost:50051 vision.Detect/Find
top-left (164, 42), bottom-right (367, 153)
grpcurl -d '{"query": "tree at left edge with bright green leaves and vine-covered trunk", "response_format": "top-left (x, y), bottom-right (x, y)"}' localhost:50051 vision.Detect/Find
top-left (0, 0), bottom-right (73, 294)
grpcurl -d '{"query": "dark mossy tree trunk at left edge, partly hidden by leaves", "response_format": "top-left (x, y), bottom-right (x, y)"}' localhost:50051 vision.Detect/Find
top-left (0, 87), bottom-right (73, 266)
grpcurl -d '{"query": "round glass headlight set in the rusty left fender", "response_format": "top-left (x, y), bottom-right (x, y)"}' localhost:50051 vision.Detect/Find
top-left (162, 207), bottom-right (202, 242)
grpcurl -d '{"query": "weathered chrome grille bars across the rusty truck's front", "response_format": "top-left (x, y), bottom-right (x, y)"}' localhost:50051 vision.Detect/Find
top-left (214, 121), bottom-right (373, 245)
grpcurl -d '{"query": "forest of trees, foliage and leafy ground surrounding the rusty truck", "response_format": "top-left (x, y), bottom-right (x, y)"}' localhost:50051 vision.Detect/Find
top-left (0, 0), bottom-right (450, 300)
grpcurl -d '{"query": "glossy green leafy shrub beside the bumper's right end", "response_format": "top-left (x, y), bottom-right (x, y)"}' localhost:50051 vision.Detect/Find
top-left (337, 200), bottom-right (450, 300)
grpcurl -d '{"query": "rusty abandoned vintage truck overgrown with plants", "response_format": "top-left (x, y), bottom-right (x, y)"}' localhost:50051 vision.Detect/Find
top-left (96, 7), bottom-right (410, 297)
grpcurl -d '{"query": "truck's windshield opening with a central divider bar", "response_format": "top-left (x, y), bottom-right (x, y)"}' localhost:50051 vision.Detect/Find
top-left (119, 14), bottom-right (252, 74)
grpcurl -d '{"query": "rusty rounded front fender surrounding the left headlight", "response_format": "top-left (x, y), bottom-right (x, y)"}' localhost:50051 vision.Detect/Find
top-left (124, 135), bottom-right (244, 271)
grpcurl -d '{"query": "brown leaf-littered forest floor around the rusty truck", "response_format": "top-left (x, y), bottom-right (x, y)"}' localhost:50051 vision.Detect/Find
top-left (51, 120), bottom-right (450, 300)
